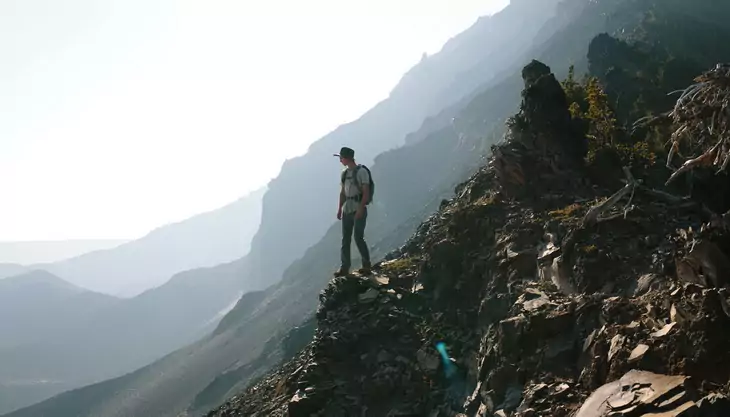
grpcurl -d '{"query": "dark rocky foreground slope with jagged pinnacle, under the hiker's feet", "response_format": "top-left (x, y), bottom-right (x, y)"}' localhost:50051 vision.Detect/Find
top-left (208, 61), bottom-right (730, 417)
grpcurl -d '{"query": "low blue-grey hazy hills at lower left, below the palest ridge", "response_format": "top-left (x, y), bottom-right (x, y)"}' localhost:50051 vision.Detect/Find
top-left (0, 263), bottom-right (242, 413)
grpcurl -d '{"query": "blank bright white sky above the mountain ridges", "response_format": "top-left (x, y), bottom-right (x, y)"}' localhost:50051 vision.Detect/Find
top-left (0, 0), bottom-right (508, 241)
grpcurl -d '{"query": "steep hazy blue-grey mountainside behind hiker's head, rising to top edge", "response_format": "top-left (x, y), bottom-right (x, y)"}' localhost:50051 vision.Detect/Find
top-left (239, 0), bottom-right (558, 289)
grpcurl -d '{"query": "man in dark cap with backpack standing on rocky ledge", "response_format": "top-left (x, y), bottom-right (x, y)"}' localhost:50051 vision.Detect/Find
top-left (334, 147), bottom-right (373, 277)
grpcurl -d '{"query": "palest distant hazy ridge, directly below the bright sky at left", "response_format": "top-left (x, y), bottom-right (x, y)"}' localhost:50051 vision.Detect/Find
top-left (33, 188), bottom-right (266, 297)
